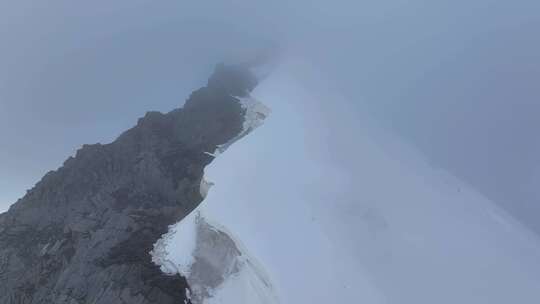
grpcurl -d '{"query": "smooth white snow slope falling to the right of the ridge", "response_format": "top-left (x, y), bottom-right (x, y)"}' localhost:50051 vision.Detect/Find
top-left (162, 60), bottom-right (540, 304)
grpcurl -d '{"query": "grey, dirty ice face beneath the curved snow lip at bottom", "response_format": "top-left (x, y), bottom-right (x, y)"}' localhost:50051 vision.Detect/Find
top-left (187, 213), bottom-right (279, 304)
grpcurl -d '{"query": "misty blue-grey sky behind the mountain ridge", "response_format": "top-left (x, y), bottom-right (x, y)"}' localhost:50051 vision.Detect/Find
top-left (0, 0), bottom-right (540, 232)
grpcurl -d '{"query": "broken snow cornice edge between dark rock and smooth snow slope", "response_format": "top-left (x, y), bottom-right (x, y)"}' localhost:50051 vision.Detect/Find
top-left (150, 95), bottom-right (279, 304)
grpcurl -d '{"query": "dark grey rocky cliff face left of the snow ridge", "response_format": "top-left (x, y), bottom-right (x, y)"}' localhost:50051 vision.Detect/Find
top-left (0, 65), bottom-right (257, 304)
